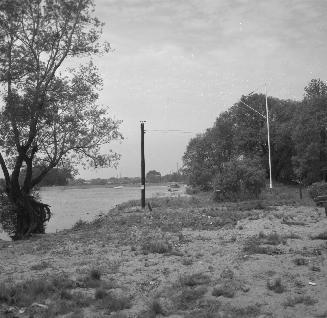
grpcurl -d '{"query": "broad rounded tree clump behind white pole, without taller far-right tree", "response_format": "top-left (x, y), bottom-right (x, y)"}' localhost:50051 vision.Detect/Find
top-left (184, 94), bottom-right (298, 187)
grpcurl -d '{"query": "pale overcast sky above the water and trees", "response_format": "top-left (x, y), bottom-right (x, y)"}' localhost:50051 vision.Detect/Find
top-left (3, 0), bottom-right (327, 178)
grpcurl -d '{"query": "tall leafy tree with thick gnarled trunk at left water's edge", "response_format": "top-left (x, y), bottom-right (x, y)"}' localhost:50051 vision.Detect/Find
top-left (0, 0), bottom-right (121, 239)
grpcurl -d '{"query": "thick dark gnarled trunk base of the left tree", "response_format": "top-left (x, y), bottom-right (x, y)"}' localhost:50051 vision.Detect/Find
top-left (9, 189), bottom-right (51, 240)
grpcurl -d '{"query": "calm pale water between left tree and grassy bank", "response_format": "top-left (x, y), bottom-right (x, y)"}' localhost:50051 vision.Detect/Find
top-left (0, 185), bottom-right (184, 239)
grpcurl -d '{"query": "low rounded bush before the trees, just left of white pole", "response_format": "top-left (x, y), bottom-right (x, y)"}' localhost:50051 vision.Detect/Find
top-left (214, 159), bottom-right (266, 200)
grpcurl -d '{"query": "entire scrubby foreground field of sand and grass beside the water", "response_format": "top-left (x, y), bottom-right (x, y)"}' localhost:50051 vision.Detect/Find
top-left (0, 187), bottom-right (327, 318)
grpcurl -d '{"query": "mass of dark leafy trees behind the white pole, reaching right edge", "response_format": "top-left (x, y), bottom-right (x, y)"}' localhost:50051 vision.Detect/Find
top-left (183, 79), bottom-right (327, 188)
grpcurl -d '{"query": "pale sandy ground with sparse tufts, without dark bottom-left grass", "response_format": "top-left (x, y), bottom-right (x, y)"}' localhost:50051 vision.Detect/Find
top-left (0, 198), bottom-right (327, 318)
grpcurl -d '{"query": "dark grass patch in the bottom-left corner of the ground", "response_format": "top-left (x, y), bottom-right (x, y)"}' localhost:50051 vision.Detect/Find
top-left (0, 269), bottom-right (127, 318)
